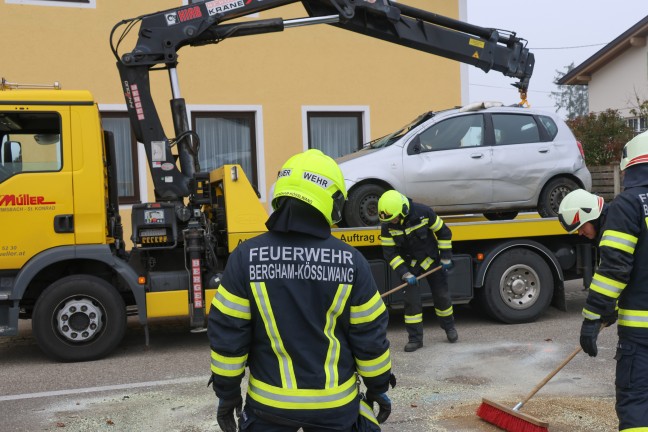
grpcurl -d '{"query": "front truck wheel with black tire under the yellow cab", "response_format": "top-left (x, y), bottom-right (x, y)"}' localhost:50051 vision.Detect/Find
top-left (32, 275), bottom-right (126, 362)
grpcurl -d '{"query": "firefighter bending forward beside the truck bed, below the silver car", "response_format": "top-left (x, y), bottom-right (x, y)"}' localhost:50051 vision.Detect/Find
top-left (378, 190), bottom-right (459, 352)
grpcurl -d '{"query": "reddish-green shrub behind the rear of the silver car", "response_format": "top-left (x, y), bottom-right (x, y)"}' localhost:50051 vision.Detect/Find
top-left (567, 108), bottom-right (634, 166)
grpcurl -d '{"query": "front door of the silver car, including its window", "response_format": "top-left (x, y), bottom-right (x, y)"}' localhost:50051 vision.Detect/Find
top-left (403, 114), bottom-right (493, 211)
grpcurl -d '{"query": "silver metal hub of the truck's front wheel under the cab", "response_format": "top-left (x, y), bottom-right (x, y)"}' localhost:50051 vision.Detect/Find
top-left (56, 298), bottom-right (103, 342)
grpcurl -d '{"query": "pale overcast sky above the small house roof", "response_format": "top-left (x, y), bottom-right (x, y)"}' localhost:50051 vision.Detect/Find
top-left (465, 0), bottom-right (648, 115)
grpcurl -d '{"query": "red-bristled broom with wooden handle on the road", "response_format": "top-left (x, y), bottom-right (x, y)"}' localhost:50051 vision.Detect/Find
top-left (477, 340), bottom-right (588, 432)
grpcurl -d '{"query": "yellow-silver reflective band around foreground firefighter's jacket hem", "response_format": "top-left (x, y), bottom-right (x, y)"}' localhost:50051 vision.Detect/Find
top-left (248, 374), bottom-right (358, 410)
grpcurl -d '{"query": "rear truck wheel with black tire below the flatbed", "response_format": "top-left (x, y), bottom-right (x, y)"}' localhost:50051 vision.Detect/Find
top-left (477, 248), bottom-right (554, 324)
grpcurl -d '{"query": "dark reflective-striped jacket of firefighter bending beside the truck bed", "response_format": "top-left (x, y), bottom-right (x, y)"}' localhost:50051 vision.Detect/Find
top-left (380, 200), bottom-right (452, 278)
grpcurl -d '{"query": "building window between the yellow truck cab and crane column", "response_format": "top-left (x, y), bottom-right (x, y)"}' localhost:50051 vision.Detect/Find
top-left (101, 112), bottom-right (141, 204)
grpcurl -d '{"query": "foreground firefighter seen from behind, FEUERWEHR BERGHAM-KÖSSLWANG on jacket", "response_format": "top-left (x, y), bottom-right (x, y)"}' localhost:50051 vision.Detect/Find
top-left (208, 149), bottom-right (395, 432)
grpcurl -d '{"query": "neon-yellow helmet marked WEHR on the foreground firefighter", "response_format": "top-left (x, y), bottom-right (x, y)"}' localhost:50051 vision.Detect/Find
top-left (272, 149), bottom-right (347, 225)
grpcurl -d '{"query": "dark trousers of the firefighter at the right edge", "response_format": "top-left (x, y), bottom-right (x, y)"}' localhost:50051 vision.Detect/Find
top-left (614, 335), bottom-right (648, 432)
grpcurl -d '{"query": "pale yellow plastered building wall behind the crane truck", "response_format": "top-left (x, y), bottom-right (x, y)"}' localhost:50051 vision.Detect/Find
top-left (0, 0), bottom-right (465, 243)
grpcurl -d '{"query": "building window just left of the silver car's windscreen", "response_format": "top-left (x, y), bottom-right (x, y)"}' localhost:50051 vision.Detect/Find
top-left (307, 111), bottom-right (363, 158)
